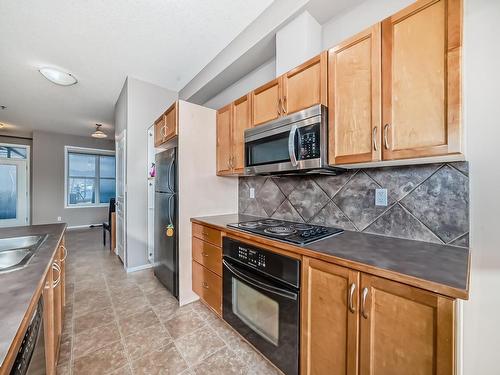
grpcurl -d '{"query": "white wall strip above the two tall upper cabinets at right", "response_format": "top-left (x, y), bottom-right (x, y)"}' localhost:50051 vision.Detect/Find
top-left (323, 0), bottom-right (415, 49)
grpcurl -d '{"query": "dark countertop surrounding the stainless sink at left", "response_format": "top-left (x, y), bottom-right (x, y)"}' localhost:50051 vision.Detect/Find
top-left (0, 223), bottom-right (66, 367)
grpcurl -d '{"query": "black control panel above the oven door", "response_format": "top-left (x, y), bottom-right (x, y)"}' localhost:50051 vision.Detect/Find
top-left (222, 237), bottom-right (300, 288)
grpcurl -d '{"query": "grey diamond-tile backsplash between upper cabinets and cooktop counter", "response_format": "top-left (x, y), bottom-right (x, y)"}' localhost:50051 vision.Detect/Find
top-left (238, 162), bottom-right (469, 247)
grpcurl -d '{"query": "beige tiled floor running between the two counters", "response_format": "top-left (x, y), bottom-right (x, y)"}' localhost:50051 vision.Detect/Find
top-left (58, 228), bottom-right (279, 375)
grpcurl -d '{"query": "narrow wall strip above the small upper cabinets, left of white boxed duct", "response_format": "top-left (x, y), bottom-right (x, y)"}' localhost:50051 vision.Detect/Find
top-left (203, 59), bottom-right (276, 109)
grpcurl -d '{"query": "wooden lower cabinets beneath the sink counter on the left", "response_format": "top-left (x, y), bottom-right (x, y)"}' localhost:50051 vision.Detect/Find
top-left (42, 238), bottom-right (67, 375)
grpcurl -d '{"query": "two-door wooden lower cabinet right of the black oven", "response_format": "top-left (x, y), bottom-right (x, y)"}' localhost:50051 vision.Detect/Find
top-left (301, 257), bottom-right (455, 375)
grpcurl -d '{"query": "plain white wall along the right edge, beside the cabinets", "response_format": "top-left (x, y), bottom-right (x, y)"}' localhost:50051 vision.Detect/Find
top-left (463, 0), bottom-right (500, 375)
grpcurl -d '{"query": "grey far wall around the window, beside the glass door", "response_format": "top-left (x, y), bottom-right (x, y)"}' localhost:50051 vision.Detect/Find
top-left (31, 131), bottom-right (115, 226)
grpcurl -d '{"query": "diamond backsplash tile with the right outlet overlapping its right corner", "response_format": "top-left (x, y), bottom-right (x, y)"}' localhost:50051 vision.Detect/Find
top-left (333, 172), bottom-right (394, 230)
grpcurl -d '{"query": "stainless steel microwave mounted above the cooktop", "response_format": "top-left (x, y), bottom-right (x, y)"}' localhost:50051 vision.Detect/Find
top-left (245, 105), bottom-right (339, 175)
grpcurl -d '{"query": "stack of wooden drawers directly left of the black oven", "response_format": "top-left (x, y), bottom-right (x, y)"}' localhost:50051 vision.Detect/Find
top-left (192, 223), bottom-right (222, 316)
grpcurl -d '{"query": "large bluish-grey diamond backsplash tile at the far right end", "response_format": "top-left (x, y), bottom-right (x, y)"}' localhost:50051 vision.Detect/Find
top-left (401, 166), bottom-right (469, 243)
